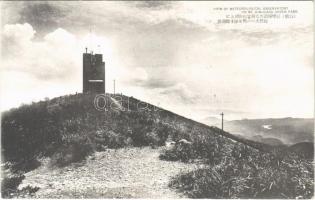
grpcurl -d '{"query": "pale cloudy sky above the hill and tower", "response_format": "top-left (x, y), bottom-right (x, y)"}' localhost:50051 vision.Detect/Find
top-left (0, 1), bottom-right (314, 119)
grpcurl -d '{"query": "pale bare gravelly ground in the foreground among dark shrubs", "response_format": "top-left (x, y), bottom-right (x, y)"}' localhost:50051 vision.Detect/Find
top-left (19, 147), bottom-right (196, 198)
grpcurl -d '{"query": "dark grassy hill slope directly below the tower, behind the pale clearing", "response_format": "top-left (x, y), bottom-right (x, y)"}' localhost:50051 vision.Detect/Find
top-left (1, 94), bottom-right (268, 165)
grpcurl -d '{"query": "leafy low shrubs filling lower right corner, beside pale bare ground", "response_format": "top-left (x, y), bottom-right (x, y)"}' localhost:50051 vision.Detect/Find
top-left (170, 144), bottom-right (314, 198)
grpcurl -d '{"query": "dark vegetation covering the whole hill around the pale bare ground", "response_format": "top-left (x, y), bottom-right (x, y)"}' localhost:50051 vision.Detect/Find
top-left (1, 94), bottom-right (314, 198)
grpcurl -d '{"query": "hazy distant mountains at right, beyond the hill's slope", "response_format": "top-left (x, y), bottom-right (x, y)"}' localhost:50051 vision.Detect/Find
top-left (201, 117), bottom-right (314, 146)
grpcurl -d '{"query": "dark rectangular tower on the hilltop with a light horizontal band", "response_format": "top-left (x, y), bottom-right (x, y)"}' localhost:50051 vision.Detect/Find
top-left (83, 50), bottom-right (105, 94)
